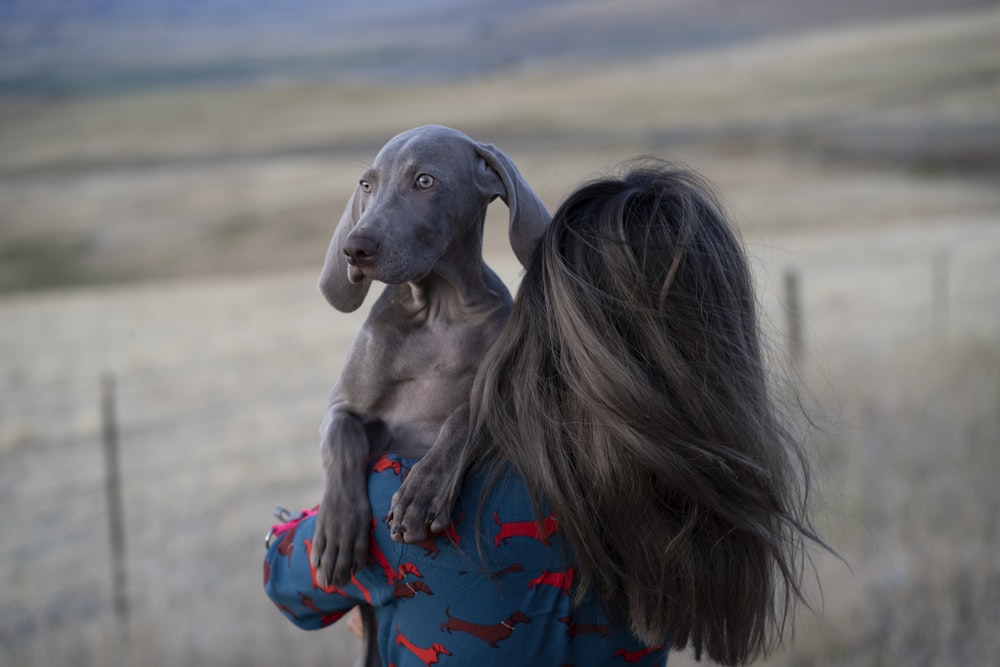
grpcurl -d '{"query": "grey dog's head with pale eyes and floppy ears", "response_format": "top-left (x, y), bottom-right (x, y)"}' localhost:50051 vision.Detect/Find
top-left (319, 125), bottom-right (550, 312)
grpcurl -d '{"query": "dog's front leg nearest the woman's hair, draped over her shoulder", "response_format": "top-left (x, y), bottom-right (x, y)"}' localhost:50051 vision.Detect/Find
top-left (387, 403), bottom-right (469, 543)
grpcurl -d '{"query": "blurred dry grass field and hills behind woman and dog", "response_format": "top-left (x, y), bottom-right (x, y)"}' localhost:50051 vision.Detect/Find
top-left (0, 0), bottom-right (1000, 666)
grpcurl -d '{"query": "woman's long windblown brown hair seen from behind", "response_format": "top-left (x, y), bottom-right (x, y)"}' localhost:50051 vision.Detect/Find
top-left (463, 162), bottom-right (818, 664)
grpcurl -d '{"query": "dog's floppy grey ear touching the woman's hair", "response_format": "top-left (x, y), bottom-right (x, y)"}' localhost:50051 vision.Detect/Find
top-left (476, 144), bottom-right (552, 267)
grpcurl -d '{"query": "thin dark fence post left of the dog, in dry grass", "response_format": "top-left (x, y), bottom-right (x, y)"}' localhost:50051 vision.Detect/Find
top-left (101, 374), bottom-right (129, 628)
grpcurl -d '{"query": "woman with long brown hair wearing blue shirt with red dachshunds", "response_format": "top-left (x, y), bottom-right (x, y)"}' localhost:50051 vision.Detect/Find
top-left (269, 163), bottom-right (818, 666)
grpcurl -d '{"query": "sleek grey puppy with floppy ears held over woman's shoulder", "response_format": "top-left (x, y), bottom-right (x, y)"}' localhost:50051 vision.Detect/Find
top-left (312, 125), bottom-right (550, 585)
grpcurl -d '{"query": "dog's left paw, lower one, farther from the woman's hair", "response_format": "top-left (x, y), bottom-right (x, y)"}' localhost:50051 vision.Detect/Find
top-left (311, 494), bottom-right (372, 588)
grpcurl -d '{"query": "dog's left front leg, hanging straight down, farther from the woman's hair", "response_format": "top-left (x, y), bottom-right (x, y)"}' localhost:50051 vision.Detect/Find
top-left (312, 407), bottom-right (372, 586)
